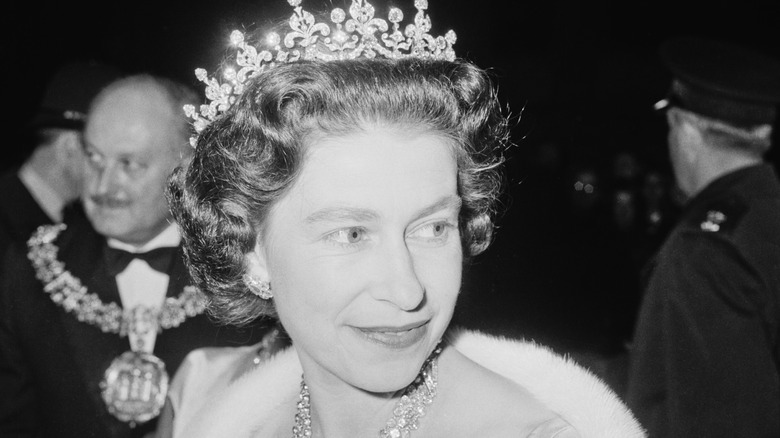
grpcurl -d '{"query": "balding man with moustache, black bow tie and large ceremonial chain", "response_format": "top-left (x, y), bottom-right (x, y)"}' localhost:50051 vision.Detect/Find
top-left (0, 75), bottom-right (274, 438)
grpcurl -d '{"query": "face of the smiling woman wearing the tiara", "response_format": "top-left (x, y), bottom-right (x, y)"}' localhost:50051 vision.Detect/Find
top-left (250, 128), bottom-right (462, 392)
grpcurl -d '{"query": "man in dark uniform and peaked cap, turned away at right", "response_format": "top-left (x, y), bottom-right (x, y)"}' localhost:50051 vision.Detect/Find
top-left (627, 38), bottom-right (780, 437)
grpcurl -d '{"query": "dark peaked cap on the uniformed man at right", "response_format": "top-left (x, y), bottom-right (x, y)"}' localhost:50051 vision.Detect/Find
top-left (656, 37), bottom-right (780, 127)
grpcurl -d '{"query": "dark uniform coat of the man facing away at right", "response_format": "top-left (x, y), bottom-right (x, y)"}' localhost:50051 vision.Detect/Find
top-left (627, 165), bottom-right (780, 437)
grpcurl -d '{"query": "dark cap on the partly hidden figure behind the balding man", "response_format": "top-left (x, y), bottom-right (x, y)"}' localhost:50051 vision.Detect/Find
top-left (28, 61), bottom-right (122, 129)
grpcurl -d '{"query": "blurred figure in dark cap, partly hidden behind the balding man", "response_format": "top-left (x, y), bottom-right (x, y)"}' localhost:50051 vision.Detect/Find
top-left (0, 61), bottom-right (122, 254)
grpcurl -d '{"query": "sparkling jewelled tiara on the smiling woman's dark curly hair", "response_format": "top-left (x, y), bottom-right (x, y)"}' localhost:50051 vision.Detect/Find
top-left (184, 0), bottom-right (457, 146)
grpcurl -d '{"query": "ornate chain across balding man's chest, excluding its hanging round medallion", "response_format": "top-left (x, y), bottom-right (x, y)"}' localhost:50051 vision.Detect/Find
top-left (27, 224), bottom-right (206, 336)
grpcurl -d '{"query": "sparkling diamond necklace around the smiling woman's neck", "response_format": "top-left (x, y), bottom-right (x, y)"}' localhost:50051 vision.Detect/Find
top-left (293, 347), bottom-right (441, 438)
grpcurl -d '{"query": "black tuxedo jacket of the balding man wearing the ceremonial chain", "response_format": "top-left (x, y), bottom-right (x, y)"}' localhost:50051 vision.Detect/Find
top-left (0, 210), bottom-right (264, 438)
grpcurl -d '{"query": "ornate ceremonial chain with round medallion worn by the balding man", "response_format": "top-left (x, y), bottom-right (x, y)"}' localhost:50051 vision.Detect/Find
top-left (27, 224), bottom-right (206, 427)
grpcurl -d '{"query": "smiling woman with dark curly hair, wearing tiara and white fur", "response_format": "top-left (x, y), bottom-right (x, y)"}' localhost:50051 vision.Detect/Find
top-left (163, 0), bottom-right (642, 437)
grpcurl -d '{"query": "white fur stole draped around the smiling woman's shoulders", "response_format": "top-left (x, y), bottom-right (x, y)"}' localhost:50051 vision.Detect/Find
top-left (175, 331), bottom-right (645, 438)
